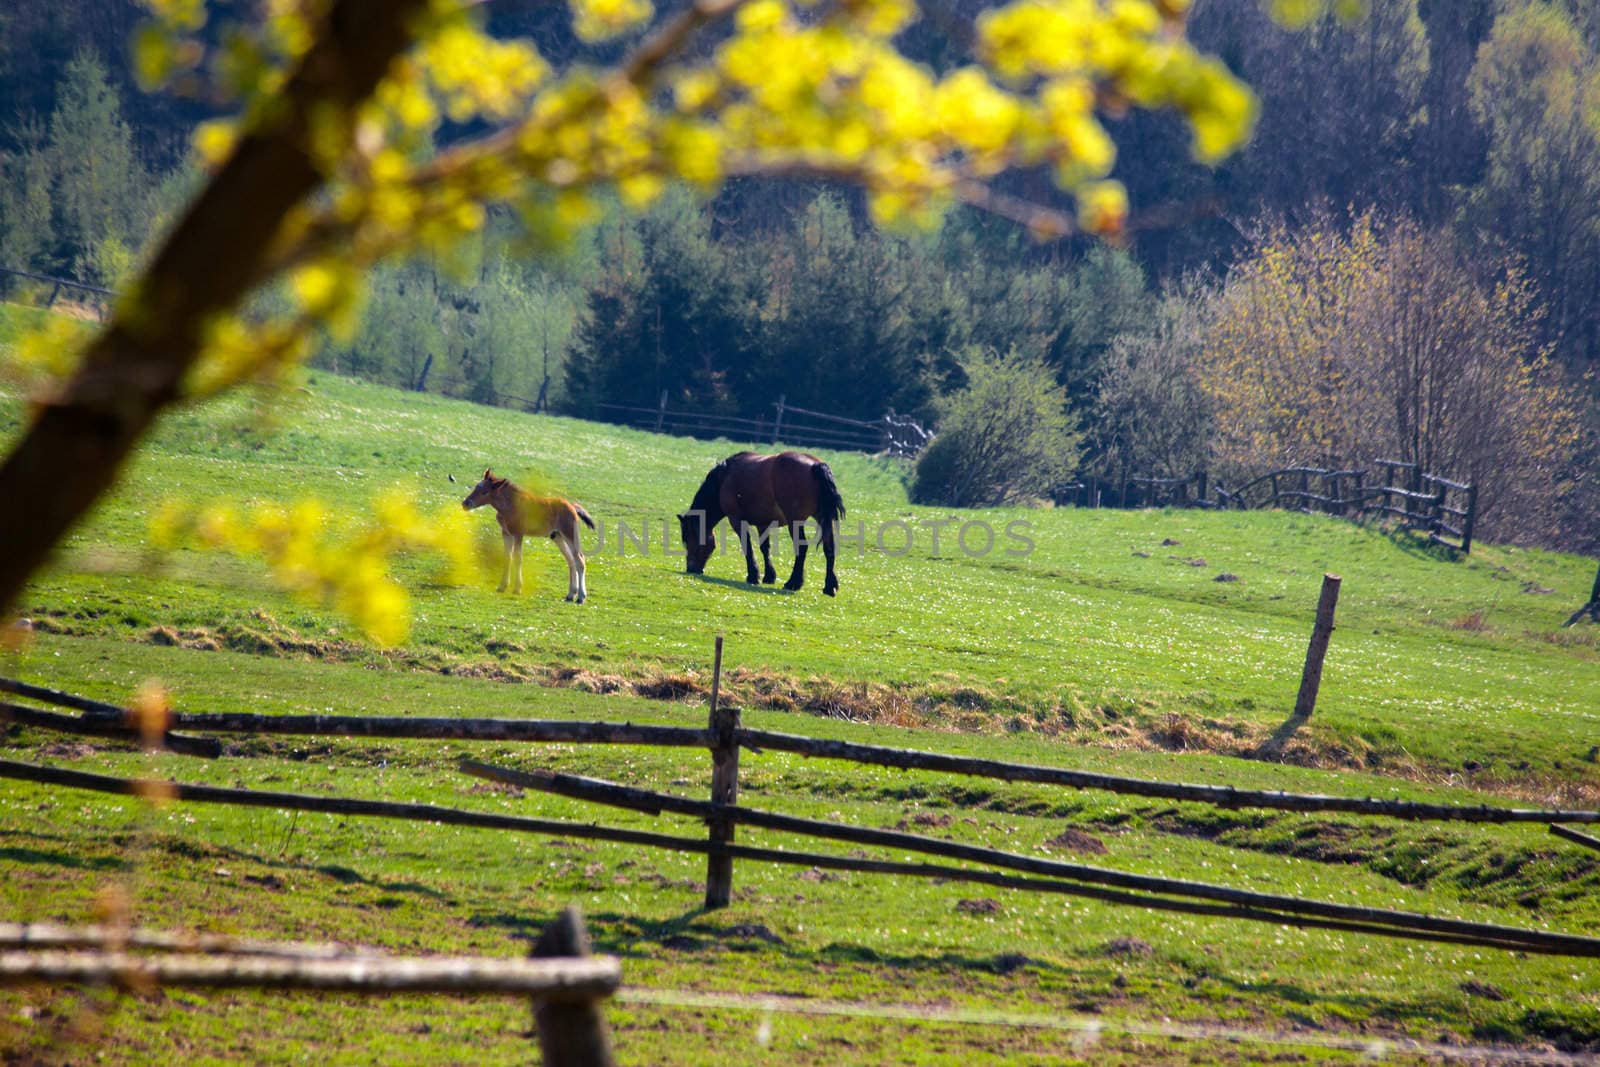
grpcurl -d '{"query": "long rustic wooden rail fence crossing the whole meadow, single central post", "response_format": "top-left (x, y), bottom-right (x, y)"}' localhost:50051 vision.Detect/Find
top-left (0, 668), bottom-right (1600, 958)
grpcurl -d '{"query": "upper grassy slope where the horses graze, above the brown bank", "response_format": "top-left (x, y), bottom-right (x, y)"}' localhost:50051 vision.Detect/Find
top-left (6, 363), bottom-right (1600, 795)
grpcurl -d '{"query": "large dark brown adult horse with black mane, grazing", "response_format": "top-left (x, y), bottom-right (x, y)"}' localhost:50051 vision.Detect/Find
top-left (678, 453), bottom-right (845, 597)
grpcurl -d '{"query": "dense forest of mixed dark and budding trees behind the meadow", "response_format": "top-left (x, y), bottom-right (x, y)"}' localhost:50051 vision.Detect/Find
top-left (0, 0), bottom-right (1600, 549)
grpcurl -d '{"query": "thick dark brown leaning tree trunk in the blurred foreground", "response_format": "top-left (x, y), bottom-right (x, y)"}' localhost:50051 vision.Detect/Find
top-left (0, 0), bottom-right (427, 613)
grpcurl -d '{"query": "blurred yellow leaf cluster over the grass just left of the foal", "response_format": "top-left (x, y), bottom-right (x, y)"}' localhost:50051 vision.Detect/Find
top-left (150, 488), bottom-right (477, 645)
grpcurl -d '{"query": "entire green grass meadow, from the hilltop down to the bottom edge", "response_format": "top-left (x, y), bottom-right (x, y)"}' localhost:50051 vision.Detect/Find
top-left (0, 313), bottom-right (1600, 1064)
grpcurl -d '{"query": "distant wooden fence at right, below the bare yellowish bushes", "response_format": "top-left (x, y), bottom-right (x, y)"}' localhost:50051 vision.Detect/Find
top-left (1058, 459), bottom-right (1478, 553)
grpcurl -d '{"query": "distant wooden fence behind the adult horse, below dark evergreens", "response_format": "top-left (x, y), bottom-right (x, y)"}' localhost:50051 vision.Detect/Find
top-left (597, 390), bottom-right (933, 458)
